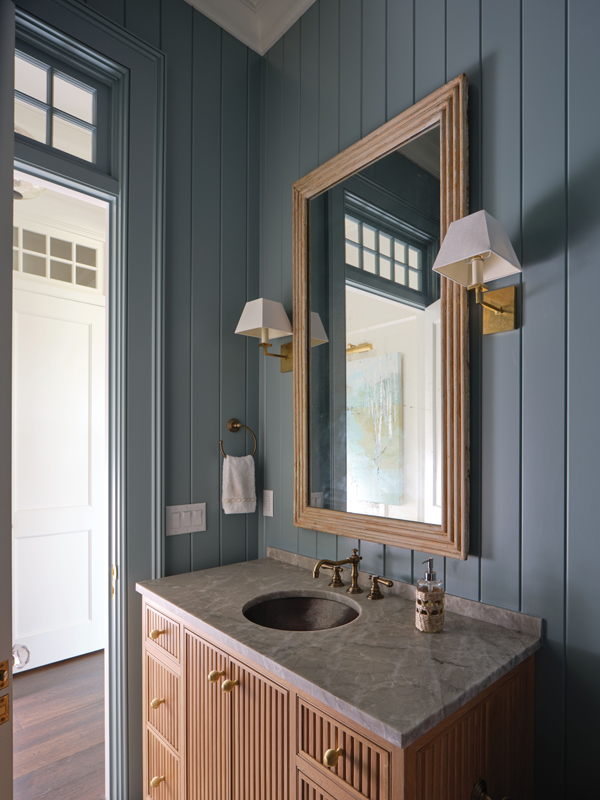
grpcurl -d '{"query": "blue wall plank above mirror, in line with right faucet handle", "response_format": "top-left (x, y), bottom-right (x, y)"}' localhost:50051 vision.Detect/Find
top-left (361, 0), bottom-right (387, 136)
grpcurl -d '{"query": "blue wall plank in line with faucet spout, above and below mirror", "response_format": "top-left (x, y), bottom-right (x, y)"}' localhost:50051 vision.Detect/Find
top-left (317, 0), bottom-right (340, 560)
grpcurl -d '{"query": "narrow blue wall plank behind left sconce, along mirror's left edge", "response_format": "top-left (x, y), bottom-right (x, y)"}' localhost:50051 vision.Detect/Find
top-left (276, 22), bottom-right (300, 552)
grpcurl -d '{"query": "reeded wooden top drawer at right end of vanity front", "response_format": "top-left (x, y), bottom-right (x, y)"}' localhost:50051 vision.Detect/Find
top-left (297, 698), bottom-right (390, 800)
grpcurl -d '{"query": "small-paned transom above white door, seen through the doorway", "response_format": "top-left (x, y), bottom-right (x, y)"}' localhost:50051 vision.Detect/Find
top-left (13, 226), bottom-right (102, 294)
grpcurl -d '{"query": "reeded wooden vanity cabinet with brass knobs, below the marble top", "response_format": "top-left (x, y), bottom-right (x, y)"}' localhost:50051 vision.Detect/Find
top-left (144, 599), bottom-right (534, 800)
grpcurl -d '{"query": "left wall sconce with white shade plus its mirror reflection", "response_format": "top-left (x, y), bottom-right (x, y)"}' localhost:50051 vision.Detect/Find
top-left (235, 297), bottom-right (329, 372)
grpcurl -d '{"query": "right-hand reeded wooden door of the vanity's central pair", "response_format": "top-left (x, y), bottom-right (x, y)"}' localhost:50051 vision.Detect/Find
top-left (227, 659), bottom-right (289, 800)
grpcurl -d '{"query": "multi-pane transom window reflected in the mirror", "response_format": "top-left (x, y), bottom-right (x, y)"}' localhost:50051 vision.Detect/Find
top-left (344, 213), bottom-right (423, 292)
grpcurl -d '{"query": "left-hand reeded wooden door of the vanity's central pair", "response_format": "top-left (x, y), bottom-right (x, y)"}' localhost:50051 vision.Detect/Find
top-left (185, 630), bottom-right (231, 800)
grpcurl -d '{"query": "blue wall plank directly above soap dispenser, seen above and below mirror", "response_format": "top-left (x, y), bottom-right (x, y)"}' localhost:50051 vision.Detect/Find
top-left (414, 0), bottom-right (446, 582)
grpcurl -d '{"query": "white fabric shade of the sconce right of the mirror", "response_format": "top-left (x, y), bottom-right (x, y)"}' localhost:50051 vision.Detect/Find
top-left (433, 211), bottom-right (522, 286)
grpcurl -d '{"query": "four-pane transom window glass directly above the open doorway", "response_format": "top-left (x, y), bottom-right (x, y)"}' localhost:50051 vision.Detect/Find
top-left (15, 50), bottom-right (97, 162)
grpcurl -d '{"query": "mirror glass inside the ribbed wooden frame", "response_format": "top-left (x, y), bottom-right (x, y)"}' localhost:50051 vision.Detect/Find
top-left (309, 127), bottom-right (442, 525)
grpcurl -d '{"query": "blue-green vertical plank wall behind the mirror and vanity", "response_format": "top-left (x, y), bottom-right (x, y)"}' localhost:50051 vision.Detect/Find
top-left (259, 0), bottom-right (600, 798)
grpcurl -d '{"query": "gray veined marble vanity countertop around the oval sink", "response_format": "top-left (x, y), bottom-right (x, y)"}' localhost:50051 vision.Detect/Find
top-left (137, 559), bottom-right (541, 748)
